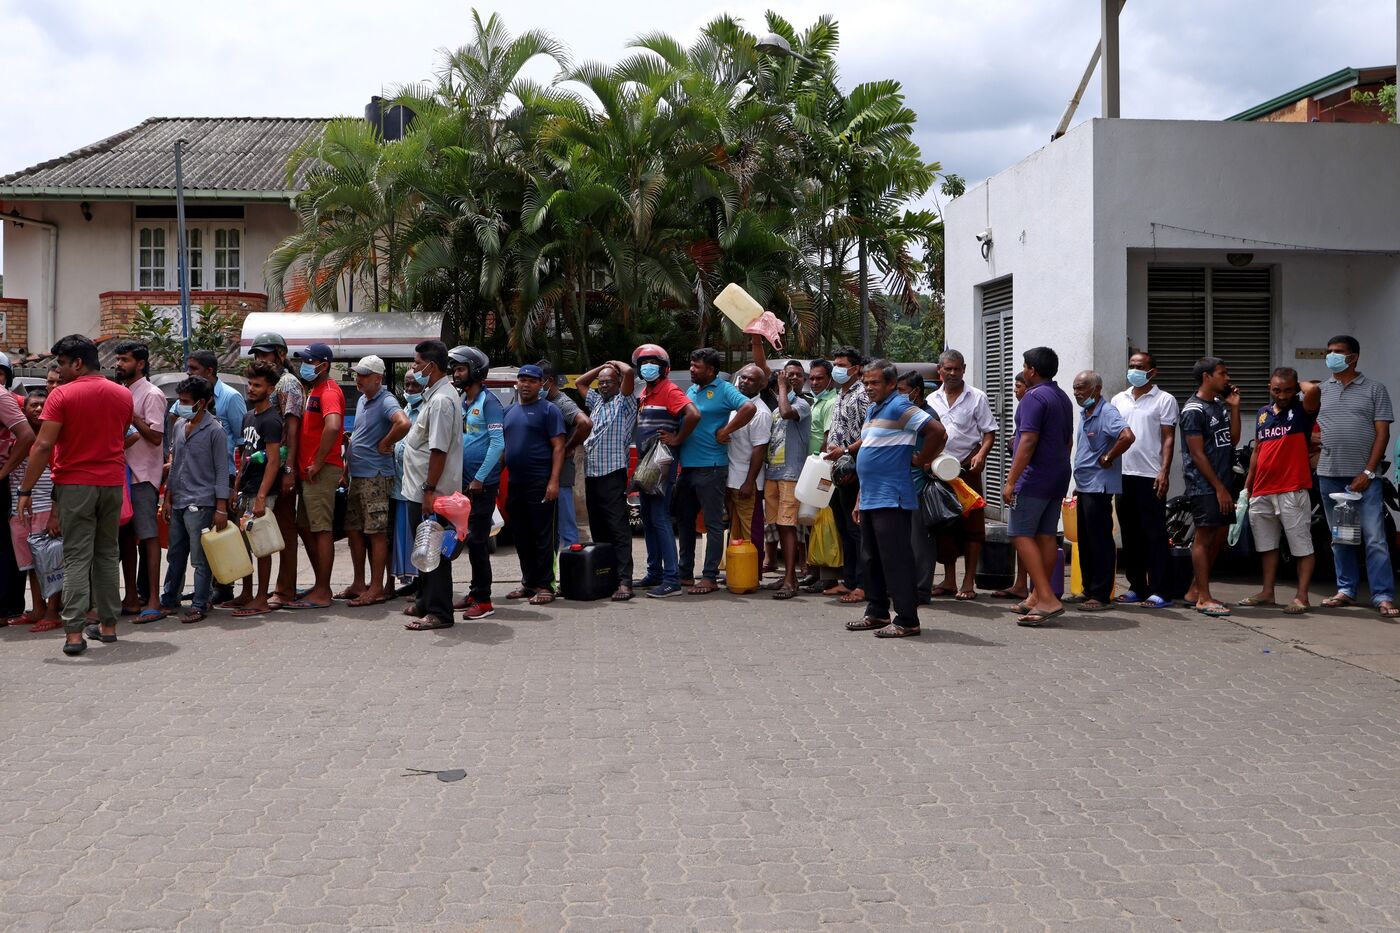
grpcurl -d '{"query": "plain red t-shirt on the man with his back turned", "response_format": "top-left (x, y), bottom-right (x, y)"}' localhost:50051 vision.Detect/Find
top-left (41, 374), bottom-right (132, 486)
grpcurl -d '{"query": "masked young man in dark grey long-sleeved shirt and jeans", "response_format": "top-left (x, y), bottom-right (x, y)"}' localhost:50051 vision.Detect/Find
top-left (161, 375), bottom-right (228, 623)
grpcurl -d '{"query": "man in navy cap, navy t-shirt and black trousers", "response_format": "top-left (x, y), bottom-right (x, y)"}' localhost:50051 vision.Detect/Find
top-left (505, 363), bottom-right (564, 605)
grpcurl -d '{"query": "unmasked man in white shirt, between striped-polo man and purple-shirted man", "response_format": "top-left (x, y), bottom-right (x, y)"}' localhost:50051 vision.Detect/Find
top-left (928, 350), bottom-right (997, 600)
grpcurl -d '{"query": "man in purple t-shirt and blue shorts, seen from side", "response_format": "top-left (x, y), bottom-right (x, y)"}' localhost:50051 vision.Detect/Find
top-left (1002, 346), bottom-right (1074, 626)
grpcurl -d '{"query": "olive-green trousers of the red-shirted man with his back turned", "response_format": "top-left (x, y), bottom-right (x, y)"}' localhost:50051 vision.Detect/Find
top-left (53, 483), bottom-right (122, 635)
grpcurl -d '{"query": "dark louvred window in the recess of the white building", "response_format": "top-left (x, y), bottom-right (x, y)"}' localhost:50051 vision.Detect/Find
top-left (1147, 266), bottom-right (1274, 410)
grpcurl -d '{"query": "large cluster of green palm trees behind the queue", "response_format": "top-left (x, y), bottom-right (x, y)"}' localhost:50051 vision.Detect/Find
top-left (265, 11), bottom-right (963, 366)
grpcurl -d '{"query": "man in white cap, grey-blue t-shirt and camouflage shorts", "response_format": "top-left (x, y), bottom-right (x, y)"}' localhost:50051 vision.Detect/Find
top-left (336, 356), bottom-right (409, 607)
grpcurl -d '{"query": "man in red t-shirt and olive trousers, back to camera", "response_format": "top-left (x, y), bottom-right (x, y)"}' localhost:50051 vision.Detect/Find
top-left (18, 333), bottom-right (133, 654)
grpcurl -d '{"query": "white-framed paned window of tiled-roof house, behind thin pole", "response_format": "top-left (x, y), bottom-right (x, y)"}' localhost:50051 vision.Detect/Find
top-left (133, 220), bottom-right (244, 291)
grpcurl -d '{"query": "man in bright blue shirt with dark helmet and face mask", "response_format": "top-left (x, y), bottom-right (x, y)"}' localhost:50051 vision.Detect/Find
top-left (447, 346), bottom-right (505, 622)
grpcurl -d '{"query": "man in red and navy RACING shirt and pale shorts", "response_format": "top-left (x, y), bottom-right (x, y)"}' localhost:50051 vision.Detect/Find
top-left (1240, 366), bottom-right (1322, 615)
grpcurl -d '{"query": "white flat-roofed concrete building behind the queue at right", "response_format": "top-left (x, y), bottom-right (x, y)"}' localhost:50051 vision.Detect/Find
top-left (946, 119), bottom-right (1400, 507)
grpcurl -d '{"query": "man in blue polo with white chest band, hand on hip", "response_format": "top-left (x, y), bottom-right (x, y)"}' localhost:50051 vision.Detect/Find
top-left (846, 360), bottom-right (948, 639)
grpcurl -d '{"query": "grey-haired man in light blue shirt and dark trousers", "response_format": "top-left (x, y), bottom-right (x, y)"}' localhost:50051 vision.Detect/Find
top-left (1074, 370), bottom-right (1134, 612)
